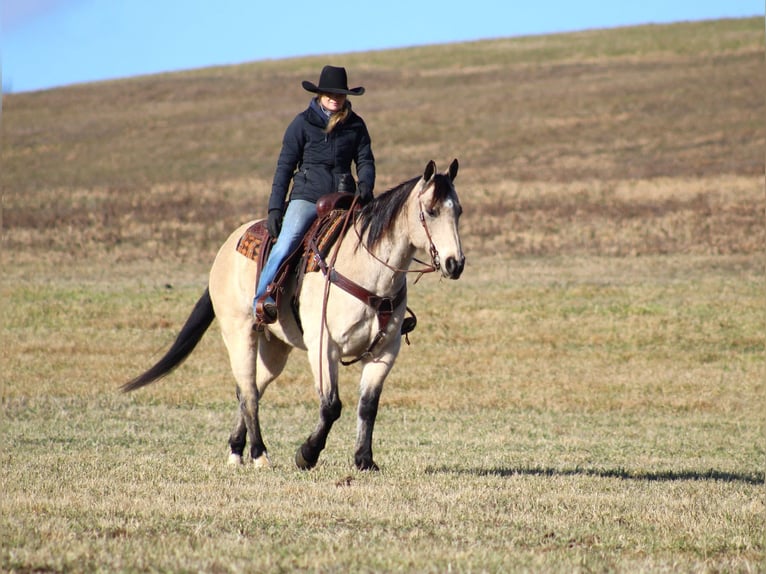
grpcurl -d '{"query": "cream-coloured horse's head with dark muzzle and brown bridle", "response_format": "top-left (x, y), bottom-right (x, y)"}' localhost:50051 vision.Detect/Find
top-left (410, 159), bottom-right (465, 279)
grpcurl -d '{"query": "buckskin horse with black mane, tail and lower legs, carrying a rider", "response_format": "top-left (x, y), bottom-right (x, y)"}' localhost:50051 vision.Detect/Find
top-left (122, 159), bottom-right (465, 471)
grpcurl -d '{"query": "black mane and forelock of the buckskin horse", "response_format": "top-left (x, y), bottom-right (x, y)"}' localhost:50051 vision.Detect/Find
top-left (356, 174), bottom-right (460, 249)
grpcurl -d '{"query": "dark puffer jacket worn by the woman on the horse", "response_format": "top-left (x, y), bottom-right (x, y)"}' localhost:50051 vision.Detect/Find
top-left (269, 99), bottom-right (375, 211)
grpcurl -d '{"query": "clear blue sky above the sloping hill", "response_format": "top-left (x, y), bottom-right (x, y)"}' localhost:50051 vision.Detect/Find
top-left (0, 0), bottom-right (764, 92)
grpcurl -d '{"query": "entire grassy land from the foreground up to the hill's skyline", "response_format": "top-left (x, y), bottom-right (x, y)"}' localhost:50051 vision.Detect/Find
top-left (0, 15), bottom-right (766, 572)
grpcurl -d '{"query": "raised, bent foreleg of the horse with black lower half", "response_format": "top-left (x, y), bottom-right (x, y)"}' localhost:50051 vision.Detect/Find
top-left (295, 353), bottom-right (343, 470)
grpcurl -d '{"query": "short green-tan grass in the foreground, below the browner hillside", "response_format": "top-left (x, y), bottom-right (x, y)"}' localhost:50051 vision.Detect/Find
top-left (0, 257), bottom-right (766, 572)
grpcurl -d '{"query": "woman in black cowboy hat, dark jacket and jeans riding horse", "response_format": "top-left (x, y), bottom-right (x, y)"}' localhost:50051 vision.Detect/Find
top-left (253, 66), bottom-right (375, 323)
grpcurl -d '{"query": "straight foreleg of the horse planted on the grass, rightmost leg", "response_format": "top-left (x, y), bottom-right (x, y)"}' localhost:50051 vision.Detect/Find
top-left (354, 345), bottom-right (398, 470)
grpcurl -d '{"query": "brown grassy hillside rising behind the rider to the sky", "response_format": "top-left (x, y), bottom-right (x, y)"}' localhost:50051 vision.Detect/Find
top-left (0, 18), bottom-right (766, 258)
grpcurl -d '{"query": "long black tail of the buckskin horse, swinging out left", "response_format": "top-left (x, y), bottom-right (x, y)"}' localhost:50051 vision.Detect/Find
top-left (120, 289), bottom-right (215, 393)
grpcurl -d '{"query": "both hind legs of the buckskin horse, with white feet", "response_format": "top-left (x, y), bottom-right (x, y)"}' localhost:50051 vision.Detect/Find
top-left (224, 327), bottom-right (291, 467)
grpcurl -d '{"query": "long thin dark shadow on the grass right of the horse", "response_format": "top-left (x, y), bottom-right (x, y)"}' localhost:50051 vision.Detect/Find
top-left (426, 466), bottom-right (766, 484)
